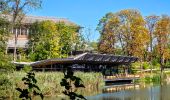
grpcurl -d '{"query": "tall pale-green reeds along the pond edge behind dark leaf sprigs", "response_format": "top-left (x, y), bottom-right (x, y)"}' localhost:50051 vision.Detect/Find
top-left (0, 72), bottom-right (104, 98)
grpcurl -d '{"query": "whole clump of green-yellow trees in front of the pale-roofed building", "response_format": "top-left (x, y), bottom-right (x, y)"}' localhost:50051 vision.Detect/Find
top-left (29, 21), bottom-right (80, 61)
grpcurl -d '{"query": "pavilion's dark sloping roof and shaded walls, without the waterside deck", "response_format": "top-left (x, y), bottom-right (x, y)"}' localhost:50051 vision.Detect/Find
top-left (30, 53), bottom-right (138, 74)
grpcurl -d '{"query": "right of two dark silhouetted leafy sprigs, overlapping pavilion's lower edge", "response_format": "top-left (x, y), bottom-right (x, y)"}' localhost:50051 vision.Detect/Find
top-left (60, 67), bottom-right (86, 100)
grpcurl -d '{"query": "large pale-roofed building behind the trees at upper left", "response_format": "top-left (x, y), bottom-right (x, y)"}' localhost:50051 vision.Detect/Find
top-left (1, 15), bottom-right (77, 53)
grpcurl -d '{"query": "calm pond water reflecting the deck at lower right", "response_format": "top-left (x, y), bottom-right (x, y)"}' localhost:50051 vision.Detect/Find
top-left (86, 84), bottom-right (170, 100)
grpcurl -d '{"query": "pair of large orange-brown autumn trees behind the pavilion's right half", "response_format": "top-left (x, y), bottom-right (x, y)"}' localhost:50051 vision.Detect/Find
top-left (97, 9), bottom-right (149, 58)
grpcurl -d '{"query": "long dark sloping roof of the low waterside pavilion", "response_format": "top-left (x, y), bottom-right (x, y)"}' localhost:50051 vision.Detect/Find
top-left (30, 53), bottom-right (138, 66)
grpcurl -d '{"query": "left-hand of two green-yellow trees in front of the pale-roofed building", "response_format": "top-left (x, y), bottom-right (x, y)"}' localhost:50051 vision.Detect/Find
top-left (29, 21), bottom-right (60, 61)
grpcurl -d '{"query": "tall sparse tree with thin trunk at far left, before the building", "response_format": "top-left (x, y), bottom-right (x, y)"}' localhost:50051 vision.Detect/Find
top-left (0, 0), bottom-right (42, 61)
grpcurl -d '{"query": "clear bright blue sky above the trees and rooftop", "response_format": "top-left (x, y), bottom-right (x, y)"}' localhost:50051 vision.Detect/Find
top-left (28, 0), bottom-right (170, 41)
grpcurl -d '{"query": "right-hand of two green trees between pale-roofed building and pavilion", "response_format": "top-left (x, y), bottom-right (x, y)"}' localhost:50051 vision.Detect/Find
top-left (56, 22), bottom-right (80, 58)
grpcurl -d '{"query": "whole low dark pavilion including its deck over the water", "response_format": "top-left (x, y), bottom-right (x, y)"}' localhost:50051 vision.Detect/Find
top-left (14, 53), bottom-right (139, 85)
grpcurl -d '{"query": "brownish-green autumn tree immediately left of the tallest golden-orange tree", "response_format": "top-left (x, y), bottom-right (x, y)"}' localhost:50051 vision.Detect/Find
top-left (97, 13), bottom-right (119, 54)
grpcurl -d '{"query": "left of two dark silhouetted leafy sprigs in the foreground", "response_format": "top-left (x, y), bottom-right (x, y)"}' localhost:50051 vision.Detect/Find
top-left (16, 72), bottom-right (44, 100)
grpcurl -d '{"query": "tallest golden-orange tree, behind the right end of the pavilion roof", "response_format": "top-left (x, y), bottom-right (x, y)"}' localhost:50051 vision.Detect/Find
top-left (118, 9), bottom-right (148, 58)
